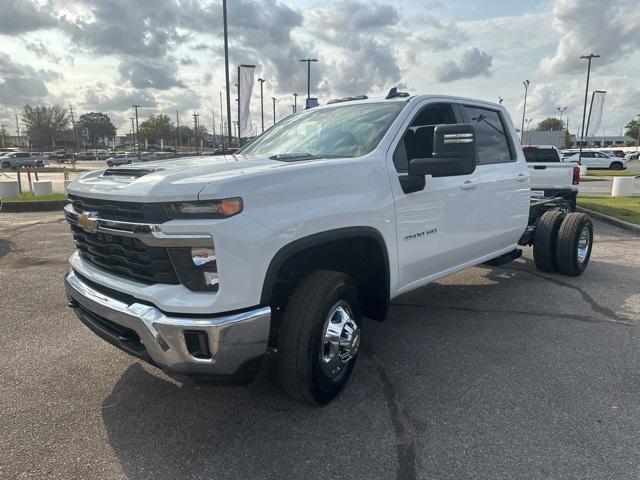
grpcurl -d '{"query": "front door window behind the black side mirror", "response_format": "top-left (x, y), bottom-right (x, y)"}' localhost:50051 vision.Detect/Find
top-left (393, 103), bottom-right (458, 173)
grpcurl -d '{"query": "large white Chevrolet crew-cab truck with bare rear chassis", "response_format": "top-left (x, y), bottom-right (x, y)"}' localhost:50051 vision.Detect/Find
top-left (65, 89), bottom-right (593, 404)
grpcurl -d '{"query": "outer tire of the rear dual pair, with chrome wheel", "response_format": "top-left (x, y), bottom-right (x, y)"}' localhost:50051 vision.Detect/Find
top-left (556, 213), bottom-right (593, 277)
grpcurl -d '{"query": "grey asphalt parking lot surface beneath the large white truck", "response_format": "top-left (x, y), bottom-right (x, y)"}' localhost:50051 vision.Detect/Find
top-left (0, 213), bottom-right (640, 480)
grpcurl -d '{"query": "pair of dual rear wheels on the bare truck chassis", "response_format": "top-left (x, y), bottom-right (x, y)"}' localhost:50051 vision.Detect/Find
top-left (533, 211), bottom-right (593, 277)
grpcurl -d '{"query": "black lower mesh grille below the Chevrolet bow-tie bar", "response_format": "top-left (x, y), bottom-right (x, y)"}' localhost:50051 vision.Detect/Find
top-left (71, 224), bottom-right (179, 284)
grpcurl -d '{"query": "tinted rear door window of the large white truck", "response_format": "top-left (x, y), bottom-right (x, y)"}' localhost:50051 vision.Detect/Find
top-left (463, 105), bottom-right (515, 165)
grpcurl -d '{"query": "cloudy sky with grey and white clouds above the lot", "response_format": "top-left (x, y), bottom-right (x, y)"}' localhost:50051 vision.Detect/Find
top-left (0, 0), bottom-right (640, 135)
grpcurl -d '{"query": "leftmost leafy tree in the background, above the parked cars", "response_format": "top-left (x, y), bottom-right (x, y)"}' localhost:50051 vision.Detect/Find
top-left (22, 105), bottom-right (69, 148)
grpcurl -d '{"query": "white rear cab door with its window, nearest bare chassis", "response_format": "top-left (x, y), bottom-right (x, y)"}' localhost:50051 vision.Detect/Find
top-left (460, 104), bottom-right (531, 255)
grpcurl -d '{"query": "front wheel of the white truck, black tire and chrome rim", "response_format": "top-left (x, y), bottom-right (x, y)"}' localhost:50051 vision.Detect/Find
top-left (278, 270), bottom-right (362, 405)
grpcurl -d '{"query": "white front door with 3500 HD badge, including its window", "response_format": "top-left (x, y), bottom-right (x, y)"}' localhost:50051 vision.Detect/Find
top-left (391, 100), bottom-right (481, 290)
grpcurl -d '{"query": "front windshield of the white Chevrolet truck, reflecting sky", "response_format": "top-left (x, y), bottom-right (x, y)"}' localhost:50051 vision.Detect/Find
top-left (239, 102), bottom-right (406, 161)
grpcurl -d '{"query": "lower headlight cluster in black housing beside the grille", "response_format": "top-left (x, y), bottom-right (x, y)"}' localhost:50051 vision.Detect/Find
top-left (168, 247), bottom-right (219, 292)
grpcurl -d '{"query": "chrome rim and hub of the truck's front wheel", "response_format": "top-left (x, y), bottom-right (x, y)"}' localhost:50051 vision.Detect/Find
top-left (320, 300), bottom-right (360, 378)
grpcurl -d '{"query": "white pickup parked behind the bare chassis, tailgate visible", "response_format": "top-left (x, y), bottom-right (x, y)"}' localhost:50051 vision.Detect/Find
top-left (522, 145), bottom-right (580, 212)
